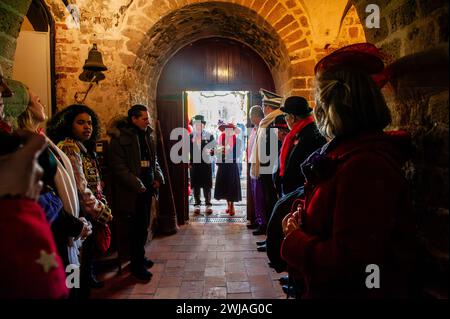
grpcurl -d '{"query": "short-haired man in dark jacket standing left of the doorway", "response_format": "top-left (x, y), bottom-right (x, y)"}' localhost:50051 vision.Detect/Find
top-left (109, 104), bottom-right (164, 281)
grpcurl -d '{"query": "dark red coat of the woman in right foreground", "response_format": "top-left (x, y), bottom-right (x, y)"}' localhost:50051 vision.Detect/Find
top-left (281, 132), bottom-right (415, 298)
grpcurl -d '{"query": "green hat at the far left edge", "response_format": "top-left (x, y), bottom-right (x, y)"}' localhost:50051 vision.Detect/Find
top-left (3, 79), bottom-right (30, 127)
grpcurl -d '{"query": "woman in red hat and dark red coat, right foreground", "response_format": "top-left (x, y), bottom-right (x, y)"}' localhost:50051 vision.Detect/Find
top-left (281, 44), bottom-right (415, 298)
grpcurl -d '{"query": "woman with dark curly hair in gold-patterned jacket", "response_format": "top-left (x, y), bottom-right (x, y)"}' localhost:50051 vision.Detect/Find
top-left (47, 104), bottom-right (112, 300)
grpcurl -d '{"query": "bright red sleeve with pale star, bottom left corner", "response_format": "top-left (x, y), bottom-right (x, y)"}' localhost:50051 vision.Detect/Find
top-left (0, 199), bottom-right (69, 299)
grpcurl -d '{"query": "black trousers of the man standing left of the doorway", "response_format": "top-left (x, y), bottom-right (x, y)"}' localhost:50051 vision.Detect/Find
top-left (129, 191), bottom-right (153, 267)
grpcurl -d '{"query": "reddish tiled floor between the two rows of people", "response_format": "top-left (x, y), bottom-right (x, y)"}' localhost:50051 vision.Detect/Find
top-left (92, 223), bottom-right (286, 299)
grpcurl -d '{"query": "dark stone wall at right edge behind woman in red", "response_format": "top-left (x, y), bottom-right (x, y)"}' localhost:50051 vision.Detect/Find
top-left (354, 0), bottom-right (449, 298)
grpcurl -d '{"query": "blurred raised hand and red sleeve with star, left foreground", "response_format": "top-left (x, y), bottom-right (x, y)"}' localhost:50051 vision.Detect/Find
top-left (0, 132), bottom-right (69, 299)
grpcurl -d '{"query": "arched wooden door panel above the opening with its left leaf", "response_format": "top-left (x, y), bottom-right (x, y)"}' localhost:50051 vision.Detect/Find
top-left (156, 38), bottom-right (275, 225)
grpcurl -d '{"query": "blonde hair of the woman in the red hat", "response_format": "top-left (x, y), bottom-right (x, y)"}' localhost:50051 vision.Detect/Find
top-left (314, 69), bottom-right (391, 138)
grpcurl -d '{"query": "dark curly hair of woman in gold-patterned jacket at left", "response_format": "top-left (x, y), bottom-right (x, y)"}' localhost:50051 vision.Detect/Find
top-left (46, 104), bottom-right (100, 151)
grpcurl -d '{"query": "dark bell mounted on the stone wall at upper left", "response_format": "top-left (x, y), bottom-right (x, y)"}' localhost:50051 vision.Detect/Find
top-left (75, 43), bottom-right (108, 103)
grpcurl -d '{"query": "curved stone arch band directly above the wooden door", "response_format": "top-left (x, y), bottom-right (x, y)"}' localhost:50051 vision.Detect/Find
top-left (125, 2), bottom-right (291, 126)
